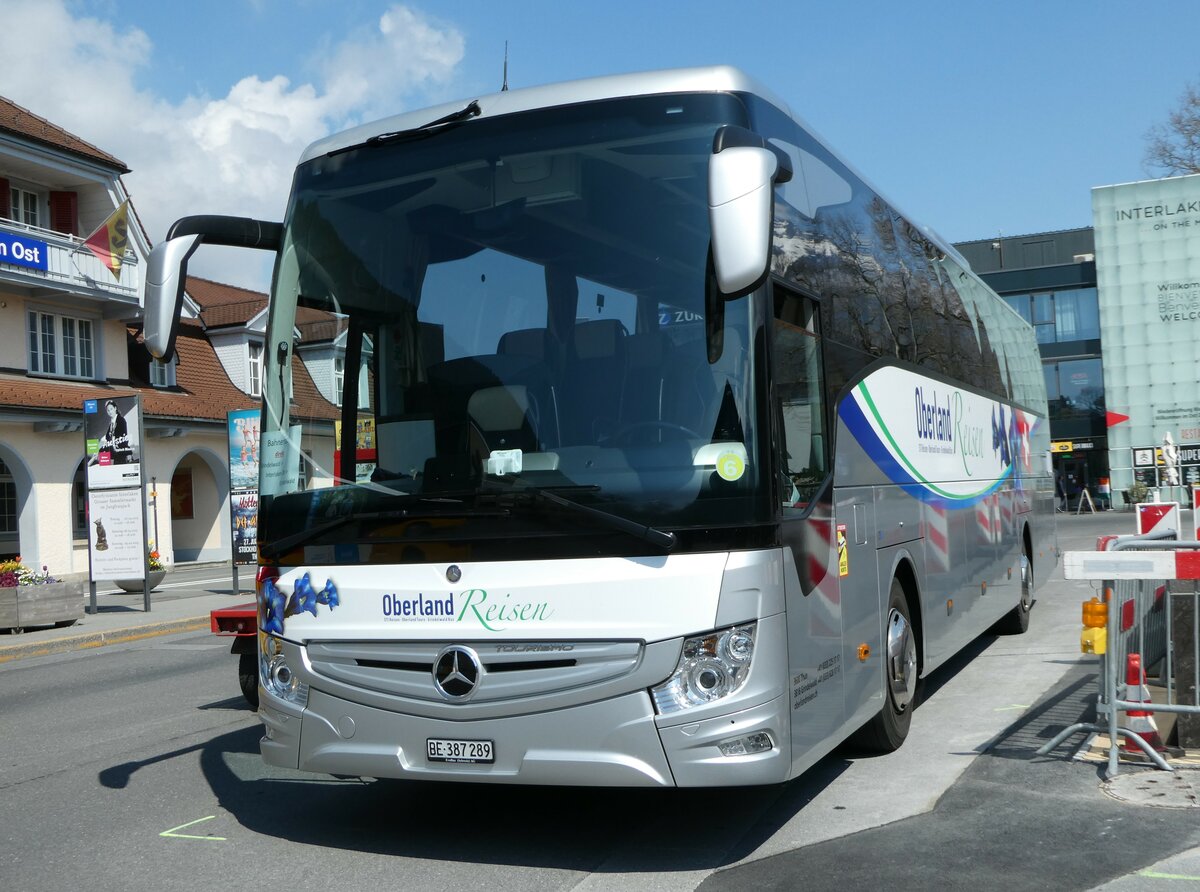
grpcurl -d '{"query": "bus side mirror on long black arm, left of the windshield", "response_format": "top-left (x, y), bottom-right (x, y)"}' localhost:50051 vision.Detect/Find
top-left (142, 215), bottom-right (283, 363)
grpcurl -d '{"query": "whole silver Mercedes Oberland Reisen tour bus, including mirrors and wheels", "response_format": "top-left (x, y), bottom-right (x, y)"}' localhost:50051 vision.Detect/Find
top-left (145, 67), bottom-right (1057, 786)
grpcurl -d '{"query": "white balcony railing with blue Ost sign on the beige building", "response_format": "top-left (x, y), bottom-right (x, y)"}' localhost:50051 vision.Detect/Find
top-left (0, 218), bottom-right (142, 306)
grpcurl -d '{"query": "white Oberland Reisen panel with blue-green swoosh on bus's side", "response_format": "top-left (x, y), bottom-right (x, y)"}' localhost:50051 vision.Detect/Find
top-left (838, 366), bottom-right (1039, 508)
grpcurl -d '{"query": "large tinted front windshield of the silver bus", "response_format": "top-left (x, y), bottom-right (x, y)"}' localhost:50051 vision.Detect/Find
top-left (259, 88), bottom-right (770, 552)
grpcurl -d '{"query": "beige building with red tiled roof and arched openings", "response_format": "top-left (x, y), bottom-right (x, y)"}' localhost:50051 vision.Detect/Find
top-left (0, 98), bottom-right (335, 575)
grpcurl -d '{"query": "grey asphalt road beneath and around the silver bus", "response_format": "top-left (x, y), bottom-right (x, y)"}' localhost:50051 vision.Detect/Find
top-left (0, 519), bottom-right (1200, 891)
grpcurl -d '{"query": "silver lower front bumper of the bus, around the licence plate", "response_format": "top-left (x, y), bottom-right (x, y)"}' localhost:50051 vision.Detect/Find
top-left (259, 690), bottom-right (791, 786)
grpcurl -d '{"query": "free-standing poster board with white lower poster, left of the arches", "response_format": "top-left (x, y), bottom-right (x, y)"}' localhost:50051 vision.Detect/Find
top-left (83, 395), bottom-right (150, 613)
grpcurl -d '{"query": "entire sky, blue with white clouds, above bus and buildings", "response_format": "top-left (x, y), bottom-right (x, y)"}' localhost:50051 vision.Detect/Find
top-left (0, 0), bottom-right (1200, 287)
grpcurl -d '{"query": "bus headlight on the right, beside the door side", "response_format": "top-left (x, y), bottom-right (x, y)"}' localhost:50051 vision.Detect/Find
top-left (650, 623), bottom-right (757, 716)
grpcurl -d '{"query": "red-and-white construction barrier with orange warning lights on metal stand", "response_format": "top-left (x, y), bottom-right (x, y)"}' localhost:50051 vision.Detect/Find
top-left (1038, 532), bottom-right (1200, 778)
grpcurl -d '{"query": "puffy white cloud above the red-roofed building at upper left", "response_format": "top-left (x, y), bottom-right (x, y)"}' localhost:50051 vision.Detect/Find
top-left (0, 0), bottom-right (464, 288)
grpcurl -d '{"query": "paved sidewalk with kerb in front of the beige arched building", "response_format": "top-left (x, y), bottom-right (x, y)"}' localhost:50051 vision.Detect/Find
top-left (0, 562), bottom-right (254, 663)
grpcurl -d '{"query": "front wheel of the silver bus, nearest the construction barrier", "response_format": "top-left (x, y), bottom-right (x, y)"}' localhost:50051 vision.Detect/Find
top-left (851, 579), bottom-right (918, 753)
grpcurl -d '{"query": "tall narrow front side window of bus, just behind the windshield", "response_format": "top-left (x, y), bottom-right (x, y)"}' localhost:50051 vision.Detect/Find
top-left (772, 283), bottom-right (829, 516)
